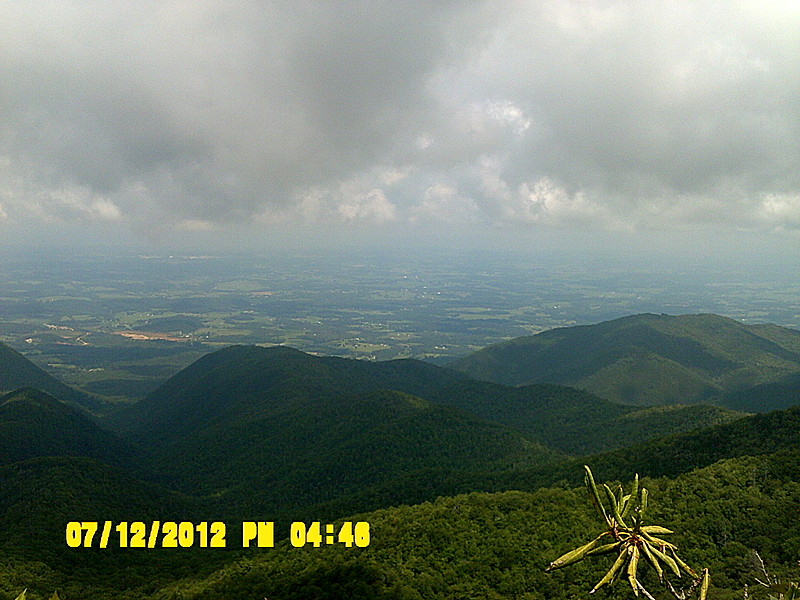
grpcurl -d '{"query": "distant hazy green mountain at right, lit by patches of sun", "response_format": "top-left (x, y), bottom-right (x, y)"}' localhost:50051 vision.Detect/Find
top-left (451, 314), bottom-right (800, 412)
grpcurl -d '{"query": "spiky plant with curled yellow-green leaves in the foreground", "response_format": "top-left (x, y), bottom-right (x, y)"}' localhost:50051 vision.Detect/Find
top-left (546, 466), bottom-right (710, 600)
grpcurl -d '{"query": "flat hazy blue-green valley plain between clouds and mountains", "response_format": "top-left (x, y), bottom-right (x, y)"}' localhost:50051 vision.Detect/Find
top-left (0, 249), bottom-right (800, 402)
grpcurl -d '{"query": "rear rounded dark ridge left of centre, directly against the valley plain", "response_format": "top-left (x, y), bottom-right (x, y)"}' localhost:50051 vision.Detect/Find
top-left (105, 346), bottom-right (465, 441)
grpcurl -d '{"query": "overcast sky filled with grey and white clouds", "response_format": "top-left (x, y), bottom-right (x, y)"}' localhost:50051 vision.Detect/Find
top-left (0, 0), bottom-right (800, 251)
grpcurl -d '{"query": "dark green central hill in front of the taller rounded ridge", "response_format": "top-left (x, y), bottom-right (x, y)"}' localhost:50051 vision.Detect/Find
top-left (115, 384), bottom-right (558, 516)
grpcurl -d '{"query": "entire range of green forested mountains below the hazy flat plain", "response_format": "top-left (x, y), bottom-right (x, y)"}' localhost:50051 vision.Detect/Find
top-left (0, 315), bottom-right (800, 600)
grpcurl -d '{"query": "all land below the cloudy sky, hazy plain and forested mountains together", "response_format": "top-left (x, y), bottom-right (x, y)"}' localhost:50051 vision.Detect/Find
top-left (0, 250), bottom-right (800, 600)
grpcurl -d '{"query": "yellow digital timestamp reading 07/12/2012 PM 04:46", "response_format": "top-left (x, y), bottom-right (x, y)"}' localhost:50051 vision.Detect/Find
top-left (66, 521), bottom-right (370, 548)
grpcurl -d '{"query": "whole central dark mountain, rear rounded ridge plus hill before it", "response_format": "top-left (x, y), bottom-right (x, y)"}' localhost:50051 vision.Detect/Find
top-left (101, 346), bottom-right (558, 511)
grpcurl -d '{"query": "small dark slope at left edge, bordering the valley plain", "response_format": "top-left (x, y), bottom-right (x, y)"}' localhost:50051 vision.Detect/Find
top-left (0, 342), bottom-right (102, 411)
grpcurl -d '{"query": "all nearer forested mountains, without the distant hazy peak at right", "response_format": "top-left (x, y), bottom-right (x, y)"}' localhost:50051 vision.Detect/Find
top-left (0, 338), bottom-right (800, 600)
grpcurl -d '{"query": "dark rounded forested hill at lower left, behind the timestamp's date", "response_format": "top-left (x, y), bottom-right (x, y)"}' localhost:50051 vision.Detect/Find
top-left (0, 456), bottom-right (203, 572)
